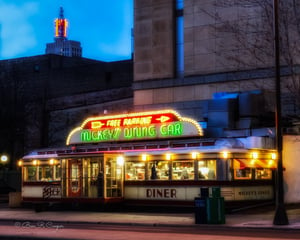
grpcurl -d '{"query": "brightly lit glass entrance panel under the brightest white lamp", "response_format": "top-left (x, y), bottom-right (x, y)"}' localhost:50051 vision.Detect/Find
top-left (105, 155), bottom-right (124, 198)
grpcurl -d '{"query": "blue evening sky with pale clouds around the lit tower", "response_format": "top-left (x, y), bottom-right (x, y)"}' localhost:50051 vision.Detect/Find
top-left (0, 0), bottom-right (133, 61)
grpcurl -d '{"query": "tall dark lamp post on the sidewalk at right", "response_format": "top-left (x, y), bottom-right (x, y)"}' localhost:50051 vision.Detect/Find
top-left (273, 0), bottom-right (289, 225)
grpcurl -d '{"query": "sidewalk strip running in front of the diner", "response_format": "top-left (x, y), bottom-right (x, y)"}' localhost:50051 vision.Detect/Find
top-left (0, 204), bottom-right (300, 230)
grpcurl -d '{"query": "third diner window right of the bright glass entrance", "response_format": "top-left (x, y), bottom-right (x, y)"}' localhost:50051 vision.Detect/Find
top-left (172, 161), bottom-right (195, 180)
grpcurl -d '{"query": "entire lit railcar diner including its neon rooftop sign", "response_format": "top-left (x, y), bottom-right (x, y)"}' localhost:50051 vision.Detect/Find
top-left (19, 110), bottom-right (276, 206)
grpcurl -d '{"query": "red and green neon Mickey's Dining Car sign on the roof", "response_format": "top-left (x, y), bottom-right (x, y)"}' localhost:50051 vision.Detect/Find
top-left (67, 110), bottom-right (203, 145)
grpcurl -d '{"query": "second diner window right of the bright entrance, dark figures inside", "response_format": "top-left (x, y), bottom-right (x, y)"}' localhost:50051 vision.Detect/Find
top-left (148, 161), bottom-right (170, 180)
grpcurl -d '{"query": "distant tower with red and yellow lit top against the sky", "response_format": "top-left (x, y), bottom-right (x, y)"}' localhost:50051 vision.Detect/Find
top-left (46, 7), bottom-right (82, 57)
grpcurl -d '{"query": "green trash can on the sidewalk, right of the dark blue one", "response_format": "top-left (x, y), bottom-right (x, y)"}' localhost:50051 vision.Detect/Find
top-left (206, 197), bottom-right (225, 224)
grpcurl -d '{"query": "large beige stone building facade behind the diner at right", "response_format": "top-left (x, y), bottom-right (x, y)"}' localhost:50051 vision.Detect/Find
top-left (133, 0), bottom-right (299, 125)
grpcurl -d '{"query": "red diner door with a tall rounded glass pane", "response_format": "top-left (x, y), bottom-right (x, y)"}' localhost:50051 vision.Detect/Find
top-left (68, 159), bottom-right (82, 197)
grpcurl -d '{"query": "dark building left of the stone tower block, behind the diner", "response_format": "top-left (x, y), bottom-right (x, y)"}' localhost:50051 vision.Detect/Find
top-left (0, 54), bottom-right (133, 171)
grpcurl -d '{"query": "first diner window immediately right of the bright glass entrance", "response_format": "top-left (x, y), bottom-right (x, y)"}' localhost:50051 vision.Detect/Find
top-left (125, 161), bottom-right (146, 180)
